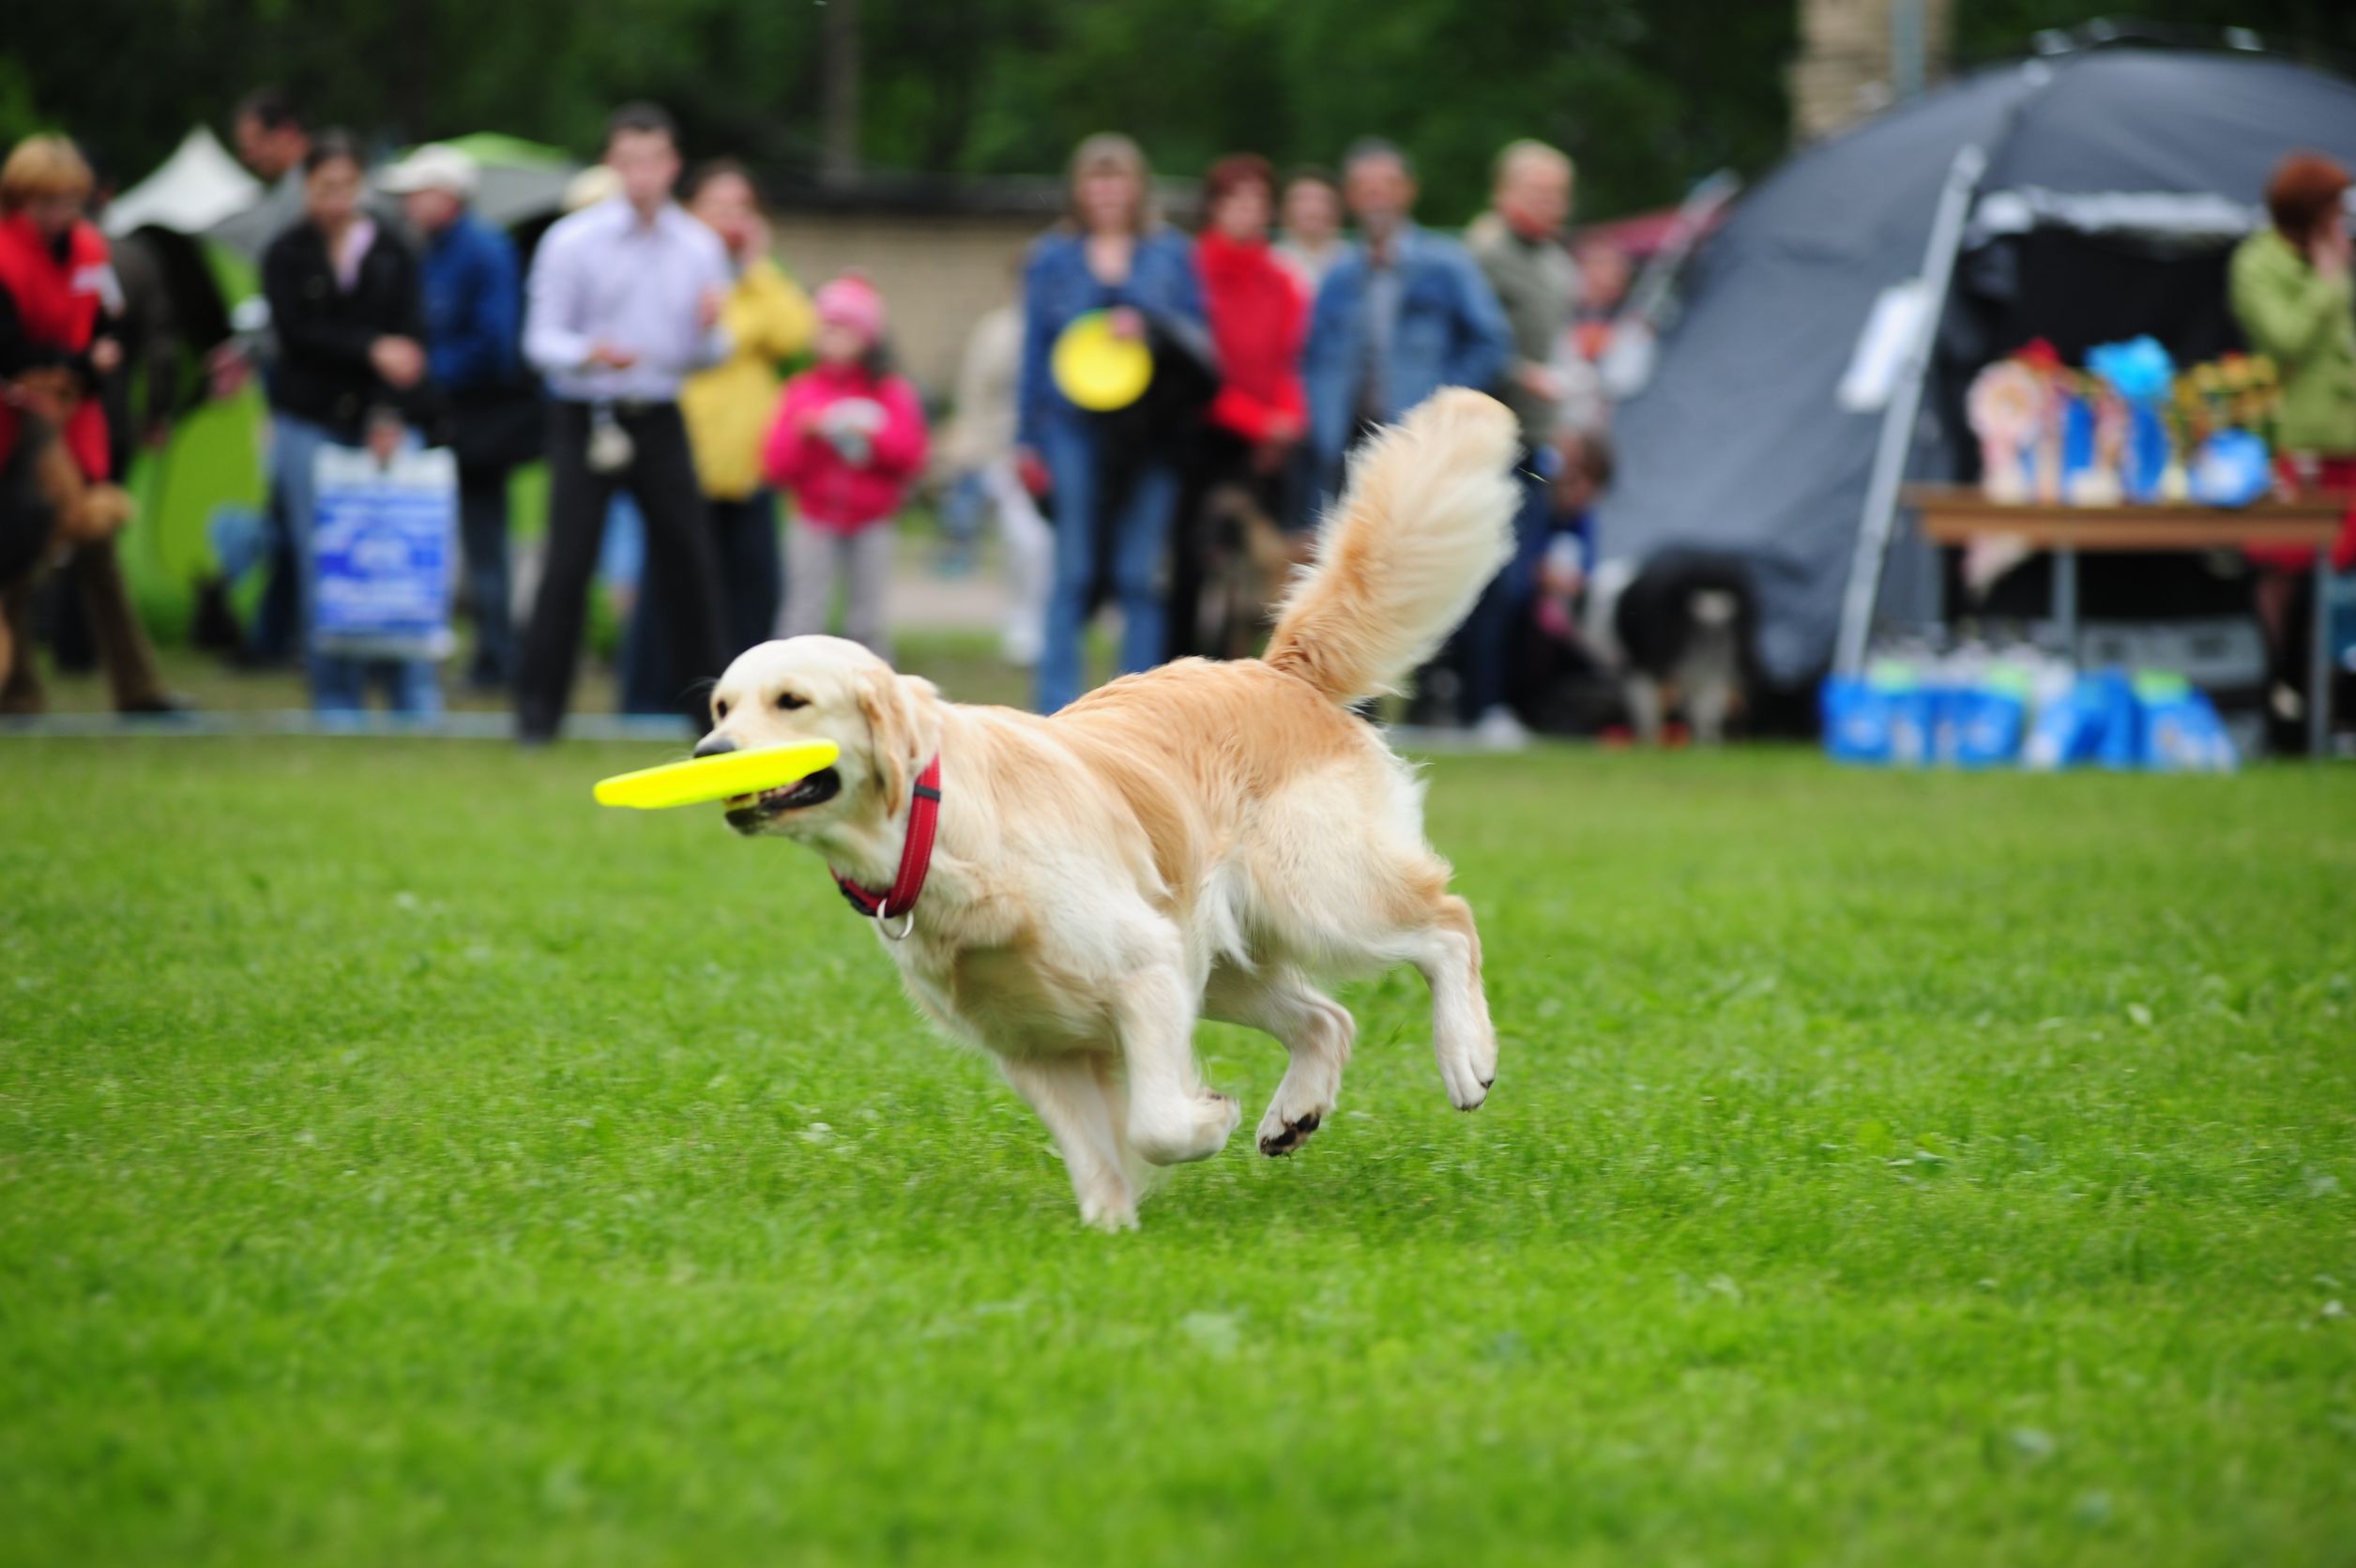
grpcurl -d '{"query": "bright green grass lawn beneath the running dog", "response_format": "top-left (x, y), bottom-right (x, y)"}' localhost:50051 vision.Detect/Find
top-left (0, 738), bottom-right (2356, 1568)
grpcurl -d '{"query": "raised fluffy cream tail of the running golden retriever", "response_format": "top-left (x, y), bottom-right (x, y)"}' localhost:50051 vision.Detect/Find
top-left (1268, 387), bottom-right (1522, 703)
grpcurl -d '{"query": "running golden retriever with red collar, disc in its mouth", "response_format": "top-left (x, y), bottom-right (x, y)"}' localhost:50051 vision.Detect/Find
top-left (697, 391), bottom-right (1520, 1228)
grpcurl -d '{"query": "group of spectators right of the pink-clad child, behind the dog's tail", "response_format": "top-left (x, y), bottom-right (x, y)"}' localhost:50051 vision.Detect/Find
top-left (950, 134), bottom-right (1628, 743)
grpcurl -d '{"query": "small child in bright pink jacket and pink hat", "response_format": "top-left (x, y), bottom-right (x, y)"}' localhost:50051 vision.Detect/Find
top-left (761, 276), bottom-right (923, 658)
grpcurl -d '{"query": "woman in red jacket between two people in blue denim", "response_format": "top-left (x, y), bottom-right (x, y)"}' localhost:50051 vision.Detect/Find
top-left (1171, 153), bottom-right (1310, 658)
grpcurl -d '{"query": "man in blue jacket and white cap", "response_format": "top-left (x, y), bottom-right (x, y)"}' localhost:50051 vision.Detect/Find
top-left (377, 146), bottom-right (524, 691)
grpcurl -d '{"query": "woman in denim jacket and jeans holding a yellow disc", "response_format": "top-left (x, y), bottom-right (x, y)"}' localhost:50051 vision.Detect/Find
top-left (1015, 134), bottom-right (1213, 712)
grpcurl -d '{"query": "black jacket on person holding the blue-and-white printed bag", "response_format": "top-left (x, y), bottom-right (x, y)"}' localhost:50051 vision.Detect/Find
top-left (262, 221), bottom-right (426, 441)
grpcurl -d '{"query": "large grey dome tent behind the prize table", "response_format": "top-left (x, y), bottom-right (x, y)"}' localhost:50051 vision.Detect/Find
top-left (1600, 47), bottom-right (2356, 686)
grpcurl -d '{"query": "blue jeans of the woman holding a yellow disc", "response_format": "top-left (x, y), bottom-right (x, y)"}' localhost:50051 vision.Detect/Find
top-left (1039, 429), bottom-right (1178, 712)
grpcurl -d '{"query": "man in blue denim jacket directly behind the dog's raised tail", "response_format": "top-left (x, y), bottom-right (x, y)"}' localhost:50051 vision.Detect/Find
top-left (1303, 137), bottom-right (1512, 495)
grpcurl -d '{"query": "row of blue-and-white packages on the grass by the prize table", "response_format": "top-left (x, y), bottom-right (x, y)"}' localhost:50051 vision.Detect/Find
top-left (1824, 647), bottom-right (2238, 773)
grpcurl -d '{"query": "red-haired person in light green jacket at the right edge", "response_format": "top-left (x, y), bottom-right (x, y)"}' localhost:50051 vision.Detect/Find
top-left (2228, 153), bottom-right (2356, 735)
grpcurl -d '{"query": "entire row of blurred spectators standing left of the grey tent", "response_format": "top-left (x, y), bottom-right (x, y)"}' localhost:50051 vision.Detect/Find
top-left (0, 92), bottom-right (1628, 743)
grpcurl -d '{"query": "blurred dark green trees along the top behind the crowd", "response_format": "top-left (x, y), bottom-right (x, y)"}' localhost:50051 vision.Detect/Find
top-left (0, 0), bottom-right (2356, 221)
